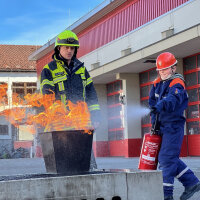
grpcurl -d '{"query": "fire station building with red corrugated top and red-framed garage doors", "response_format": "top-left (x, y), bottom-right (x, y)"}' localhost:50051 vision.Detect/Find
top-left (29, 0), bottom-right (200, 157)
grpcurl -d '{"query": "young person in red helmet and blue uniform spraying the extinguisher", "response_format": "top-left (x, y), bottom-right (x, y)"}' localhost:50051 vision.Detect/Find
top-left (149, 52), bottom-right (200, 200)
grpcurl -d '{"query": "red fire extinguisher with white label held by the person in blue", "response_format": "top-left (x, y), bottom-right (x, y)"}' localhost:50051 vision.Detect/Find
top-left (138, 114), bottom-right (162, 170)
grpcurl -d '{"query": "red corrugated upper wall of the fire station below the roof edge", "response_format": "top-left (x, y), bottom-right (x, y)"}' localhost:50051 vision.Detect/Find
top-left (78, 0), bottom-right (188, 57)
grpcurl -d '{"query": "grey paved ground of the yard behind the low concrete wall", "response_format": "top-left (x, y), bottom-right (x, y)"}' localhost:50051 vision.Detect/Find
top-left (0, 157), bottom-right (200, 200)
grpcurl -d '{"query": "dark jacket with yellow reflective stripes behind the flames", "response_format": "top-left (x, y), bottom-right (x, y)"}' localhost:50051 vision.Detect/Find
top-left (40, 56), bottom-right (100, 122)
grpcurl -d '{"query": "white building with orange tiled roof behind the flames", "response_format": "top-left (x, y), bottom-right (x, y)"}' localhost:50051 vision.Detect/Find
top-left (0, 45), bottom-right (38, 156)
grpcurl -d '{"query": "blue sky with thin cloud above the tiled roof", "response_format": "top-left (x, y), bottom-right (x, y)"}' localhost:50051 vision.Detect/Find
top-left (0, 0), bottom-right (104, 45)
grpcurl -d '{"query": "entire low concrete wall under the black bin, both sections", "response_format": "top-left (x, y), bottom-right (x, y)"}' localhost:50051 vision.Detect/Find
top-left (0, 171), bottom-right (163, 200)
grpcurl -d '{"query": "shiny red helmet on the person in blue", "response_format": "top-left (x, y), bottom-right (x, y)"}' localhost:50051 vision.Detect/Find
top-left (156, 52), bottom-right (177, 71)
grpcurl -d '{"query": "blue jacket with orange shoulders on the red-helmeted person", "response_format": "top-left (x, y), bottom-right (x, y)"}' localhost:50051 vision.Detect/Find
top-left (149, 74), bottom-right (188, 125)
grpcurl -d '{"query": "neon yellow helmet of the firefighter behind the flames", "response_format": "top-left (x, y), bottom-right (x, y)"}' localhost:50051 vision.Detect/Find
top-left (55, 30), bottom-right (80, 48)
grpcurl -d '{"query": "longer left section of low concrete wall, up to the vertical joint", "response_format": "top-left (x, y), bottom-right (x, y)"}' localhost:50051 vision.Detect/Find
top-left (0, 173), bottom-right (127, 200)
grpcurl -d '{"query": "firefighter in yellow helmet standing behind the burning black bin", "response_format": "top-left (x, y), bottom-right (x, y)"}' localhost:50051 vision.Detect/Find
top-left (40, 30), bottom-right (100, 170)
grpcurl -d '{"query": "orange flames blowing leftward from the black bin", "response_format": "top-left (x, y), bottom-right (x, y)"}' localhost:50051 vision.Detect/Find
top-left (0, 85), bottom-right (91, 134)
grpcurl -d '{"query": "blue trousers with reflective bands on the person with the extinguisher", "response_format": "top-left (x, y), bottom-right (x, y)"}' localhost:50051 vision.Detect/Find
top-left (158, 123), bottom-right (199, 196)
